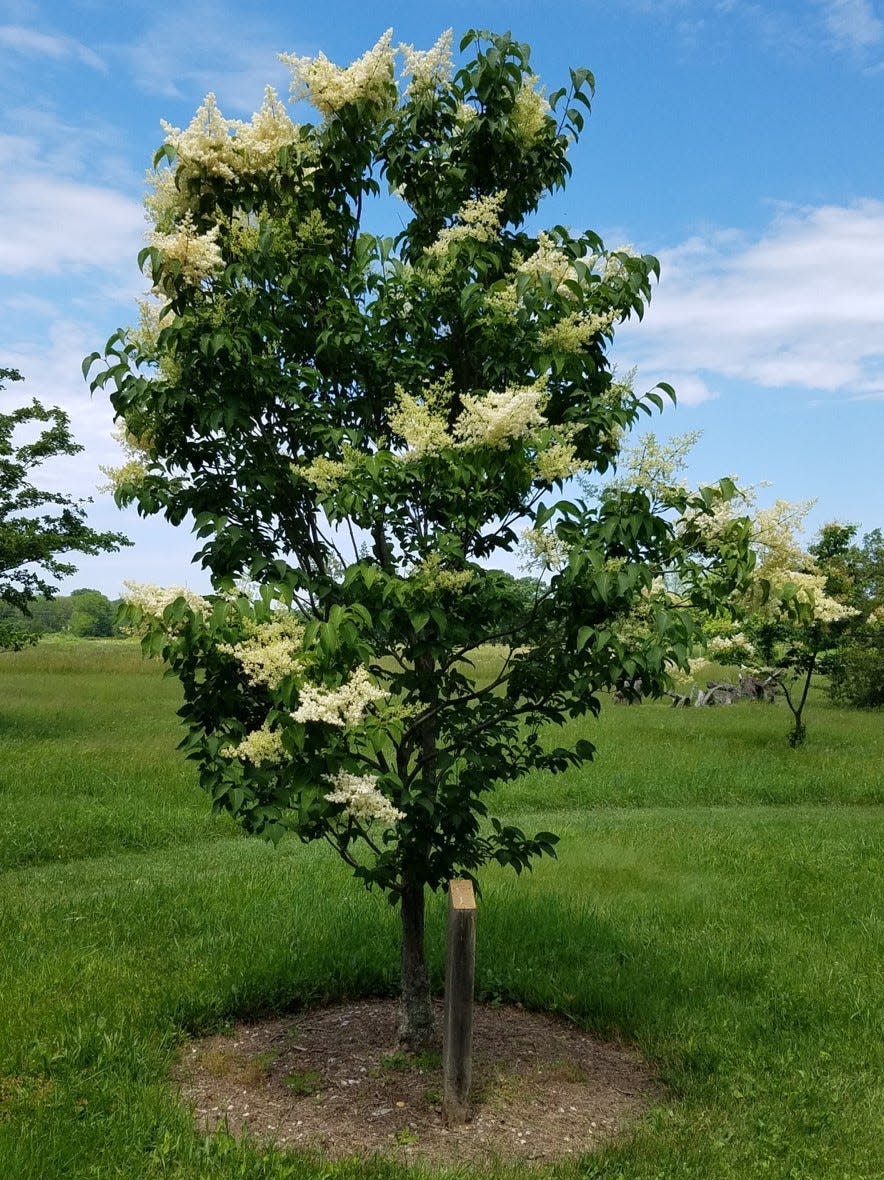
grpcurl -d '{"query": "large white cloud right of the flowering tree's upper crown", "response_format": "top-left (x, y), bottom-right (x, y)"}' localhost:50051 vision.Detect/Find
top-left (618, 199), bottom-right (884, 401)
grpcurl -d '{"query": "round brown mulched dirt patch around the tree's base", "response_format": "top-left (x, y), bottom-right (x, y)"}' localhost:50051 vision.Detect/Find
top-left (176, 999), bottom-right (662, 1166)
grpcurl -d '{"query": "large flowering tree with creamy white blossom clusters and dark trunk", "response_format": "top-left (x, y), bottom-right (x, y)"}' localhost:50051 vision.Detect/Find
top-left (85, 31), bottom-right (747, 1045)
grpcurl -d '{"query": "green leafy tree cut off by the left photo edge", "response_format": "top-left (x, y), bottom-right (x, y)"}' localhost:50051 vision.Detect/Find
top-left (0, 368), bottom-right (129, 649)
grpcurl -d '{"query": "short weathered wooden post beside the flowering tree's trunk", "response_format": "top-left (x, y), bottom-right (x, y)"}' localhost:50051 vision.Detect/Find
top-left (443, 880), bottom-right (476, 1127)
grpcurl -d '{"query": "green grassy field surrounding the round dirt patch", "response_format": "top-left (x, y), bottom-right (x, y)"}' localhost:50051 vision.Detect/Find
top-left (0, 641), bottom-right (884, 1180)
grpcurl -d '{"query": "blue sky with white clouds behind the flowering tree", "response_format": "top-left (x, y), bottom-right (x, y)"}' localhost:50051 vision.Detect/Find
top-left (0, 0), bottom-right (884, 597)
